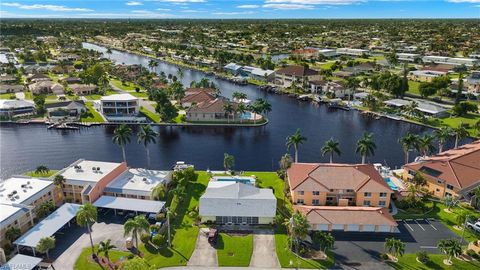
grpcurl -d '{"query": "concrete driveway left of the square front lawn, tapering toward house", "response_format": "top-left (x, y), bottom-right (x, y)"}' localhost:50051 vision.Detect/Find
top-left (187, 228), bottom-right (218, 266)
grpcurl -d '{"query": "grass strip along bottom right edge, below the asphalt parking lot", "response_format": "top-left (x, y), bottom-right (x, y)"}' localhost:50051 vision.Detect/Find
top-left (388, 254), bottom-right (480, 270)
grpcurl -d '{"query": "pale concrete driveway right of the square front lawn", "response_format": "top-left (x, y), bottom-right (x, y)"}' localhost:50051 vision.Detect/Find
top-left (250, 230), bottom-right (280, 268)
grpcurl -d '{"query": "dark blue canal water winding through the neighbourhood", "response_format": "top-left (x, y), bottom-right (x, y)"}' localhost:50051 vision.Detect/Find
top-left (0, 43), bottom-right (436, 178)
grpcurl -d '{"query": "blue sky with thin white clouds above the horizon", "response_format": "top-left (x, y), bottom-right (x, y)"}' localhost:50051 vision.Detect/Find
top-left (0, 0), bottom-right (480, 19)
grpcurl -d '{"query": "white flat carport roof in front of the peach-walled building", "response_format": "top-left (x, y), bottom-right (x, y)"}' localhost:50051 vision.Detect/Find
top-left (93, 196), bottom-right (165, 214)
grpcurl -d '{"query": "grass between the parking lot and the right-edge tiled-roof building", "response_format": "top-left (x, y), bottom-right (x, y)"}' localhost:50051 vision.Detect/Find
top-left (394, 202), bottom-right (480, 241)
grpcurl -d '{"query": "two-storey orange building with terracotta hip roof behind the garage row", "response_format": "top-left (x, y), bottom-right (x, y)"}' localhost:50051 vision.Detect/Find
top-left (287, 163), bottom-right (393, 208)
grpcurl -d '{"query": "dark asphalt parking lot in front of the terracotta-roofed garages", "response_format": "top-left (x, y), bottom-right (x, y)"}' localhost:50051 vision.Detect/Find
top-left (332, 219), bottom-right (458, 269)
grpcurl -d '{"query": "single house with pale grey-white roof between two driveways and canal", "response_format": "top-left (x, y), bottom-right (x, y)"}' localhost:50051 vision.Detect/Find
top-left (199, 181), bottom-right (277, 225)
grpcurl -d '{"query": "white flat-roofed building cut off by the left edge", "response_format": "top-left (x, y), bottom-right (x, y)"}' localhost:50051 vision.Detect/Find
top-left (0, 176), bottom-right (56, 247)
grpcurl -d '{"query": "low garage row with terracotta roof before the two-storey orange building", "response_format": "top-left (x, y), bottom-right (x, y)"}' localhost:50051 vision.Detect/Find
top-left (294, 205), bottom-right (398, 232)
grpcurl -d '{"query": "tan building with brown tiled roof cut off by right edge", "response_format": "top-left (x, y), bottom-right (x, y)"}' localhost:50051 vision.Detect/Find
top-left (403, 141), bottom-right (480, 198)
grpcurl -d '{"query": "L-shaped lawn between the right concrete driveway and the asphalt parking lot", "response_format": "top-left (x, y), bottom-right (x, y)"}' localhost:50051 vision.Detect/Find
top-left (275, 228), bottom-right (333, 269)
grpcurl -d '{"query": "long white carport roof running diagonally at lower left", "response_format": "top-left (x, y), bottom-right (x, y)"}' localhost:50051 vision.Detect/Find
top-left (13, 203), bottom-right (80, 256)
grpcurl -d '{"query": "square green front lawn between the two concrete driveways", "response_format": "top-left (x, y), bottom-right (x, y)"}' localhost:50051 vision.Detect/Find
top-left (216, 233), bottom-right (253, 266)
